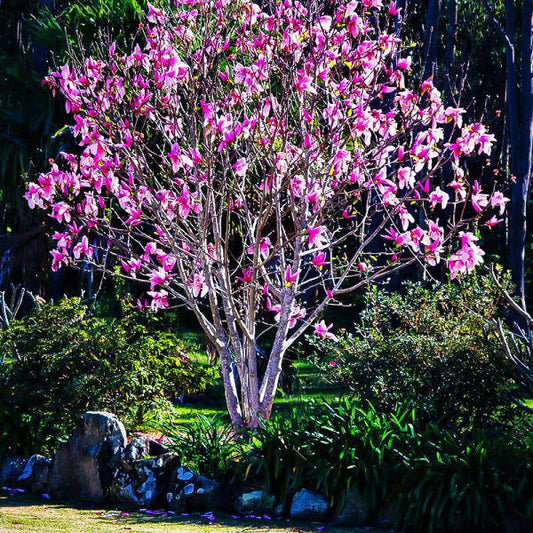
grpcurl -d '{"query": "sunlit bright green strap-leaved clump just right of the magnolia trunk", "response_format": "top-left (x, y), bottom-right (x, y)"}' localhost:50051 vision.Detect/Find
top-left (244, 400), bottom-right (414, 509)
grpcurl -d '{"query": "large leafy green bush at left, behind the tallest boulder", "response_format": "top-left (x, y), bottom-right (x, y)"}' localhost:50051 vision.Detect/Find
top-left (0, 298), bottom-right (207, 455)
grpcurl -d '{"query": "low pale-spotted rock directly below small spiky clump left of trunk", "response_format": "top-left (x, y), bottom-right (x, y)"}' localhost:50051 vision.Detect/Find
top-left (166, 466), bottom-right (224, 512)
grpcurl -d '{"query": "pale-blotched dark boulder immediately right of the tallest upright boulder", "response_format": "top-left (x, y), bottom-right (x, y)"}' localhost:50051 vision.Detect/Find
top-left (109, 453), bottom-right (177, 507)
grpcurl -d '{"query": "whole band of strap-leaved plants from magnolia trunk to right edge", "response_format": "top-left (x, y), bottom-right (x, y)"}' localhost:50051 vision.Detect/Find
top-left (241, 399), bottom-right (533, 531)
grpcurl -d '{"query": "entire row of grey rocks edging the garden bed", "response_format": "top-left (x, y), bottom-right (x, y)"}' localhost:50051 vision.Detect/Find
top-left (0, 412), bottom-right (366, 525)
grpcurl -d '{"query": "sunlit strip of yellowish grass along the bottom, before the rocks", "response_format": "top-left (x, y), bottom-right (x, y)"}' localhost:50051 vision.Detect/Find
top-left (0, 495), bottom-right (377, 533)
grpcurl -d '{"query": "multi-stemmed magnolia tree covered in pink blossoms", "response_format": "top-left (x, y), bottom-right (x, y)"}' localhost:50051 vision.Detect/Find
top-left (26, 0), bottom-right (506, 428)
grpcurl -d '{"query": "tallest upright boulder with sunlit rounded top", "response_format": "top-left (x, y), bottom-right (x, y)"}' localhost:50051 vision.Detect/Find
top-left (49, 411), bottom-right (126, 503)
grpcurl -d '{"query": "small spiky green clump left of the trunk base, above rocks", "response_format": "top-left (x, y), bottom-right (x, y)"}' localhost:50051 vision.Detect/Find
top-left (155, 414), bottom-right (240, 480)
